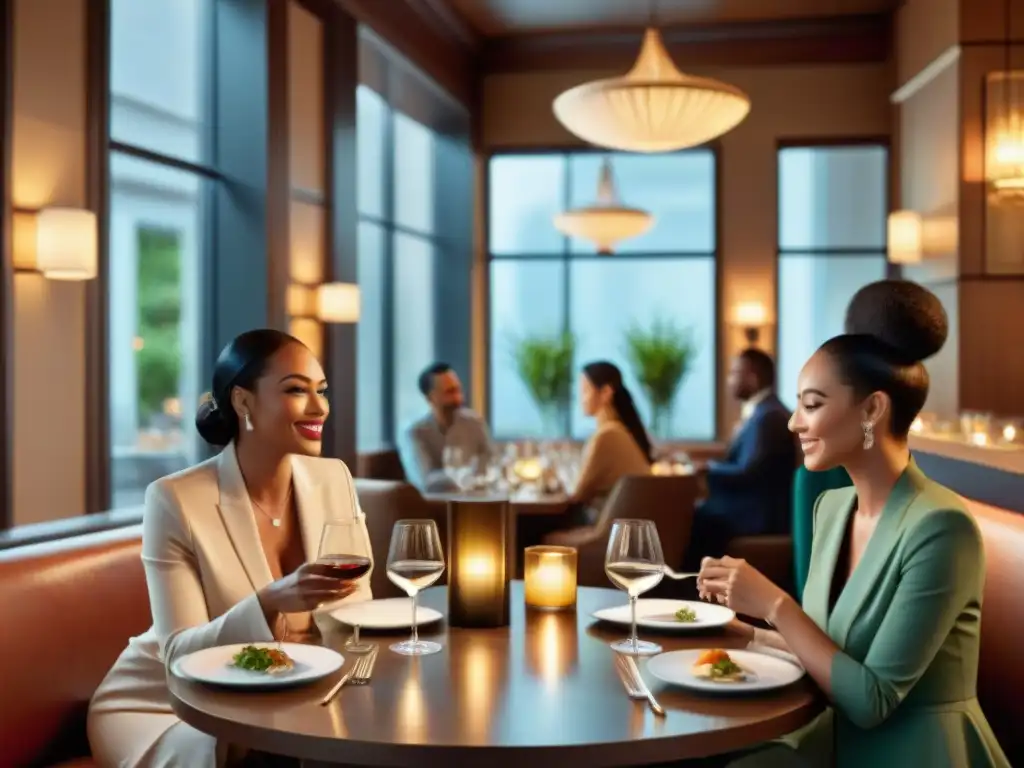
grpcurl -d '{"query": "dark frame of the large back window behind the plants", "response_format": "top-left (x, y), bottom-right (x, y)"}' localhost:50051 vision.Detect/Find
top-left (479, 141), bottom-right (725, 445)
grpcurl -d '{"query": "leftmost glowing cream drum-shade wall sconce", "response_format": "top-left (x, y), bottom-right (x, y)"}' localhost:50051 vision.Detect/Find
top-left (13, 207), bottom-right (99, 281)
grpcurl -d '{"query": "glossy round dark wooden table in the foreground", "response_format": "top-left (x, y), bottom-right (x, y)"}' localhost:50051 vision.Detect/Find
top-left (168, 582), bottom-right (821, 768)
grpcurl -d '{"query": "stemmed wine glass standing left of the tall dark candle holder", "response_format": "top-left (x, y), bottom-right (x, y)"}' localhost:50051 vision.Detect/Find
top-left (387, 520), bottom-right (444, 656)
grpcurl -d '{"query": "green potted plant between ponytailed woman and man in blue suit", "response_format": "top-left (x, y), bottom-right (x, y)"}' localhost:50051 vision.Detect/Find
top-left (626, 318), bottom-right (697, 439)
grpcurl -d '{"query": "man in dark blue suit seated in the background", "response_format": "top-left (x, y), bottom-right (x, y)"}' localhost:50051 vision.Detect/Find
top-left (687, 348), bottom-right (798, 562)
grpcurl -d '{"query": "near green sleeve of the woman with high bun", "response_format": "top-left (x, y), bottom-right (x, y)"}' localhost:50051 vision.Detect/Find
top-left (831, 509), bottom-right (984, 728)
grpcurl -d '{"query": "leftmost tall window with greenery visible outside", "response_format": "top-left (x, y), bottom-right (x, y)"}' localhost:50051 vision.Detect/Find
top-left (106, 0), bottom-right (216, 507)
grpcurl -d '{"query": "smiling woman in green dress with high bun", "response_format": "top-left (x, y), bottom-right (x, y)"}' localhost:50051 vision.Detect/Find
top-left (697, 284), bottom-right (1010, 768)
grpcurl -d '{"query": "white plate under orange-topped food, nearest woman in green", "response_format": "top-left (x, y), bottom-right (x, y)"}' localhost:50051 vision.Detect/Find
top-left (647, 648), bottom-right (804, 693)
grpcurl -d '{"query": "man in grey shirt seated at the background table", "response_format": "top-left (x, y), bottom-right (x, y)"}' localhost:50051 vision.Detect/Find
top-left (398, 362), bottom-right (492, 494)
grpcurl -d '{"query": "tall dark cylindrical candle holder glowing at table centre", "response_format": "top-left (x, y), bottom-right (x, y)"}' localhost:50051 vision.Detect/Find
top-left (447, 499), bottom-right (511, 627)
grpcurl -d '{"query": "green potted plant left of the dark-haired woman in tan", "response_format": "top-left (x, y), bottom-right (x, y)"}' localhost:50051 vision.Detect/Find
top-left (512, 333), bottom-right (575, 437)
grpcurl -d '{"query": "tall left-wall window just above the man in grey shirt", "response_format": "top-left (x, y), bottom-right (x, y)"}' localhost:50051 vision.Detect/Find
top-left (356, 86), bottom-right (445, 451)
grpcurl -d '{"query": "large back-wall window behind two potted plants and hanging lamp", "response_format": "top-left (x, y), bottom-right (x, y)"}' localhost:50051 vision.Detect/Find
top-left (488, 150), bottom-right (717, 439)
